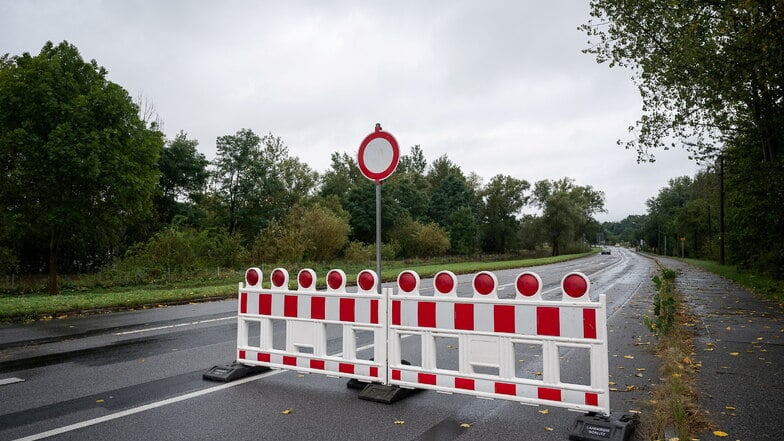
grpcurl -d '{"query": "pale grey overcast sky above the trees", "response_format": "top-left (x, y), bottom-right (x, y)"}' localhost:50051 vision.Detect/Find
top-left (0, 0), bottom-right (698, 221)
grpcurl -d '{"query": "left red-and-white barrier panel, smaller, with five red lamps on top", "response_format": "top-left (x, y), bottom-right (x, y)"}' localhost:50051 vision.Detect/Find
top-left (237, 268), bottom-right (387, 383)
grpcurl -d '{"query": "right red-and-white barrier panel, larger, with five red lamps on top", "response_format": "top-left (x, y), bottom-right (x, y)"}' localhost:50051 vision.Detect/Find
top-left (389, 271), bottom-right (610, 414)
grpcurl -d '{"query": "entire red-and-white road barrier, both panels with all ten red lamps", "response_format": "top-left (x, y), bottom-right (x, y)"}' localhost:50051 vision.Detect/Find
top-left (237, 268), bottom-right (610, 415)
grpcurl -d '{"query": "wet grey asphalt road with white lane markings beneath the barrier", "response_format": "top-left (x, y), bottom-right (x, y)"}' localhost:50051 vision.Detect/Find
top-left (0, 248), bottom-right (658, 441)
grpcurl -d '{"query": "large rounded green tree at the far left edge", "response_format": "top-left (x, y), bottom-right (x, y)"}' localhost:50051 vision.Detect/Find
top-left (0, 42), bottom-right (163, 293)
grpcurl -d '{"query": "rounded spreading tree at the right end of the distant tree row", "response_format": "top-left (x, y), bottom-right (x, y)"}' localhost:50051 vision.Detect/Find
top-left (533, 178), bottom-right (604, 256)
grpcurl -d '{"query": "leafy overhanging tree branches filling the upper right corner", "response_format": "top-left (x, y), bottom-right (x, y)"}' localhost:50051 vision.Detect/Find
top-left (581, 0), bottom-right (784, 162)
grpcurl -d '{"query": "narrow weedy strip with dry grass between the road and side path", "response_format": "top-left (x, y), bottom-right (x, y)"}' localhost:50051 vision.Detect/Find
top-left (643, 267), bottom-right (707, 440)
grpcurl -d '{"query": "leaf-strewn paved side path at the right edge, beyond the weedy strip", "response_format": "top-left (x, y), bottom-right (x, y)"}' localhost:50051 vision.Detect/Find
top-left (658, 258), bottom-right (784, 441)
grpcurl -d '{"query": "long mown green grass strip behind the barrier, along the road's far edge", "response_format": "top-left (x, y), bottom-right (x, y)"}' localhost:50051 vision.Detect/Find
top-left (0, 250), bottom-right (597, 322)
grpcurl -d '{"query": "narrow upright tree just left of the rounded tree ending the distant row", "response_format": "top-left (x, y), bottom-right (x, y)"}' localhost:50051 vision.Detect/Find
top-left (481, 175), bottom-right (531, 253)
